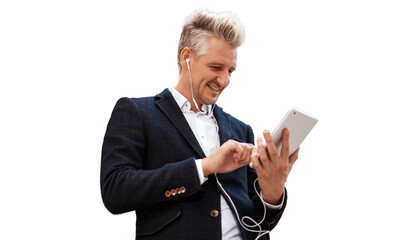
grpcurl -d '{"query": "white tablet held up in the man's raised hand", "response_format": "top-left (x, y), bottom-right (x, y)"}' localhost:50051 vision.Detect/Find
top-left (272, 108), bottom-right (318, 156)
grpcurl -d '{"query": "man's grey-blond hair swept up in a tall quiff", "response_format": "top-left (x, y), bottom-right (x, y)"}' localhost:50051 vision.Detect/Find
top-left (177, 9), bottom-right (245, 73)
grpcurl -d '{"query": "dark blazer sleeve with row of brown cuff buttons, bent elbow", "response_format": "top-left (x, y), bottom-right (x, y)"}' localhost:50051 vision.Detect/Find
top-left (100, 98), bottom-right (201, 214)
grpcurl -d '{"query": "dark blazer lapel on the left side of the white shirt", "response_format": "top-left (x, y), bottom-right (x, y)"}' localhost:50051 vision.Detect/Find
top-left (155, 89), bottom-right (206, 158)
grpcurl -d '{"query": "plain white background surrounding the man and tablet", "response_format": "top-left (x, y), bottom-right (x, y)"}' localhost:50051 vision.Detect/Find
top-left (0, 0), bottom-right (399, 239)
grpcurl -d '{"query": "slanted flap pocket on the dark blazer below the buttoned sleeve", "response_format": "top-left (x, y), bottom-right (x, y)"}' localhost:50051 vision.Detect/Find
top-left (136, 205), bottom-right (181, 236)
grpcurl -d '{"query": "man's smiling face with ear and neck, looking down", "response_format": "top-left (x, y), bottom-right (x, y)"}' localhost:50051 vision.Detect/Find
top-left (176, 37), bottom-right (237, 109)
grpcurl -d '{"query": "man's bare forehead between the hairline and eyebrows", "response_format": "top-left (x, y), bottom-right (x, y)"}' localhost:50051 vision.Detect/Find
top-left (199, 37), bottom-right (237, 67)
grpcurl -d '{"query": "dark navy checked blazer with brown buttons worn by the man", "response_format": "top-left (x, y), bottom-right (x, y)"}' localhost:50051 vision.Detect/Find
top-left (101, 89), bottom-right (287, 240)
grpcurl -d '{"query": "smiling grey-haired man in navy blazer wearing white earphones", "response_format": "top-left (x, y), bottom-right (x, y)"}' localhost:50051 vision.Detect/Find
top-left (101, 8), bottom-right (298, 240)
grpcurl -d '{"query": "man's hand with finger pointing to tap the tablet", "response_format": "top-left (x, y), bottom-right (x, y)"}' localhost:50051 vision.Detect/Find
top-left (202, 139), bottom-right (255, 177)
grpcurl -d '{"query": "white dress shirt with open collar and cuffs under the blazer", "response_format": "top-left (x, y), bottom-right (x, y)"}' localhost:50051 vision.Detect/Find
top-left (169, 87), bottom-right (285, 240)
